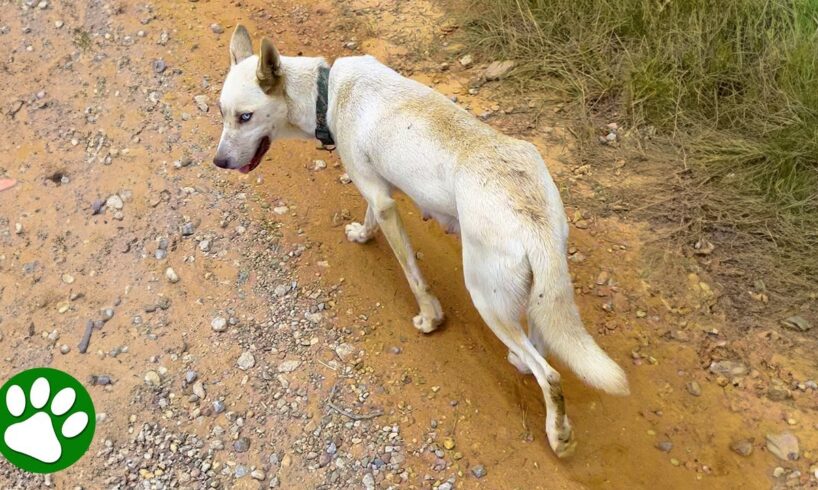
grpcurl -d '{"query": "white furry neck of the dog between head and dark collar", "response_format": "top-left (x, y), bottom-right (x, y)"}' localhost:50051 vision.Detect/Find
top-left (281, 56), bottom-right (328, 139)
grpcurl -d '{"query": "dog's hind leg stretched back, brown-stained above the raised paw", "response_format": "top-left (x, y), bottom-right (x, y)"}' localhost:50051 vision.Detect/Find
top-left (463, 243), bottom-right (576, 457)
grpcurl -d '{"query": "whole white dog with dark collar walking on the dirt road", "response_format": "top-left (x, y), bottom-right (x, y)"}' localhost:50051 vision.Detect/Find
top-left (214, 26), bottom-right (628, 456)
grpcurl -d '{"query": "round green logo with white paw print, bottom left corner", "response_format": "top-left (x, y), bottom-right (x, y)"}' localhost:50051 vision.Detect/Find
top-left (0, 368), bottom-right (96, 473)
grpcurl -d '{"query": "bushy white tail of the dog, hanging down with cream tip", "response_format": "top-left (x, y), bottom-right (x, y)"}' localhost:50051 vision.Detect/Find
top-left (526, 236), bottom-right (629, 395)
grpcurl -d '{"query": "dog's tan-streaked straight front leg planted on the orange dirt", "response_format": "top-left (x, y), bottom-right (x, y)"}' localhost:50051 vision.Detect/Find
top-left (367, 195), bottom-right (443, 333)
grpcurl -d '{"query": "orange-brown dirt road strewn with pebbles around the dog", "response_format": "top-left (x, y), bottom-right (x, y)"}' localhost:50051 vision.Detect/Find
top-left (0, 0), bottom-right (818, 489)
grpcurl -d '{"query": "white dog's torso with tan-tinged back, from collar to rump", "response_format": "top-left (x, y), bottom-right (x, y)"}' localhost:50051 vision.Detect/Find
top-left (329, 56), bottom-right (567, 241)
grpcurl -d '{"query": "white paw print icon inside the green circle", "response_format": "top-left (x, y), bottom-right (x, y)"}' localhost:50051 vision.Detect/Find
top-left (3, 377), bottom-right (88, 463)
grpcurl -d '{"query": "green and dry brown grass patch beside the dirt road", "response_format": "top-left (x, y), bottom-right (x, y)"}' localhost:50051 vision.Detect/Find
top-left (464, 0), bottom-right (818, 310)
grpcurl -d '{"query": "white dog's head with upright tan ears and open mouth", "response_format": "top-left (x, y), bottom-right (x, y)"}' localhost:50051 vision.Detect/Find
top-left (213, 25), bottom-right (288, 173)
